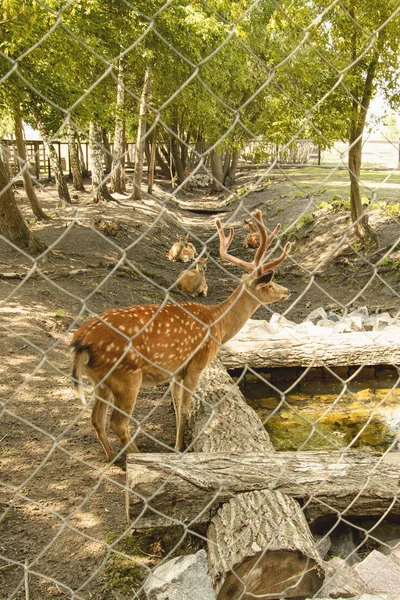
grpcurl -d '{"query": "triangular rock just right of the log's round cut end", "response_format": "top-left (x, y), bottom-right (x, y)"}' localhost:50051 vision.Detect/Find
top-left (318, 557), bottom-right (370, 598)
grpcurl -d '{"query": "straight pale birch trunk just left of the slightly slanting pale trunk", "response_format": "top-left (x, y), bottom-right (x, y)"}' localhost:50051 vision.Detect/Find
top-left (110, 58), bottom-right (126, 194)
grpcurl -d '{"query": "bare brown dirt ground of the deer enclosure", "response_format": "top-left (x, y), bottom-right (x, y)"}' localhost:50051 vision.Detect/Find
top-left (0, 170), bottom-right (400, 600)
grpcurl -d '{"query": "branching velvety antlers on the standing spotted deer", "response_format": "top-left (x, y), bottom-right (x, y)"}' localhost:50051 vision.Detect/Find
top-left (216, 210), bottom-right (290, 275)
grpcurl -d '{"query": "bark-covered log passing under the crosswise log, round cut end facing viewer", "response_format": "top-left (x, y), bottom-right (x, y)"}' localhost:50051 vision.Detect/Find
top-left (188, 361), bottom-right (324, 600)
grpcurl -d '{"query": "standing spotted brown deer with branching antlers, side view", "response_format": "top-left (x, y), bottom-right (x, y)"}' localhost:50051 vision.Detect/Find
top-left (72, 211), bottom-right (290, 461)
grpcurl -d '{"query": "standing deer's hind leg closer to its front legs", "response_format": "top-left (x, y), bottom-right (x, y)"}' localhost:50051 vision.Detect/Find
top-left (110, 371), bottom-right (142, 453)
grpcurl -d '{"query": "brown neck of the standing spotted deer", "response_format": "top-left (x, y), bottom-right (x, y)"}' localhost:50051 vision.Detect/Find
top-left (215, 283), bottom-right (261, 344)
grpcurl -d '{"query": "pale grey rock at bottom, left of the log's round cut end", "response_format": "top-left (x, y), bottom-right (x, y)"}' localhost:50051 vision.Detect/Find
top-left (143, 550), bottom-right (215, 600)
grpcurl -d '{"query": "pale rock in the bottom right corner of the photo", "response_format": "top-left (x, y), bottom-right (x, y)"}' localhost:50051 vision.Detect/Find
top-left (354, 550), bottom-right (400, 596)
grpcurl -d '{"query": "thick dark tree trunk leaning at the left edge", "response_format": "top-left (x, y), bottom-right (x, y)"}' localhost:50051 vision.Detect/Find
top-left (0, 144), bottom-right (47, 255)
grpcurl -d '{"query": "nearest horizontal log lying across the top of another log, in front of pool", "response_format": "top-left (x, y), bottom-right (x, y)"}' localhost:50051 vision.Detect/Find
top-left (127, 448), bottom-right (400, 527)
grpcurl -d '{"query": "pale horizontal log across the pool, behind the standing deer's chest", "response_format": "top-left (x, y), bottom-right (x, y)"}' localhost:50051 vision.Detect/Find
top-left (219, 327), bottom-right (400, 369)
